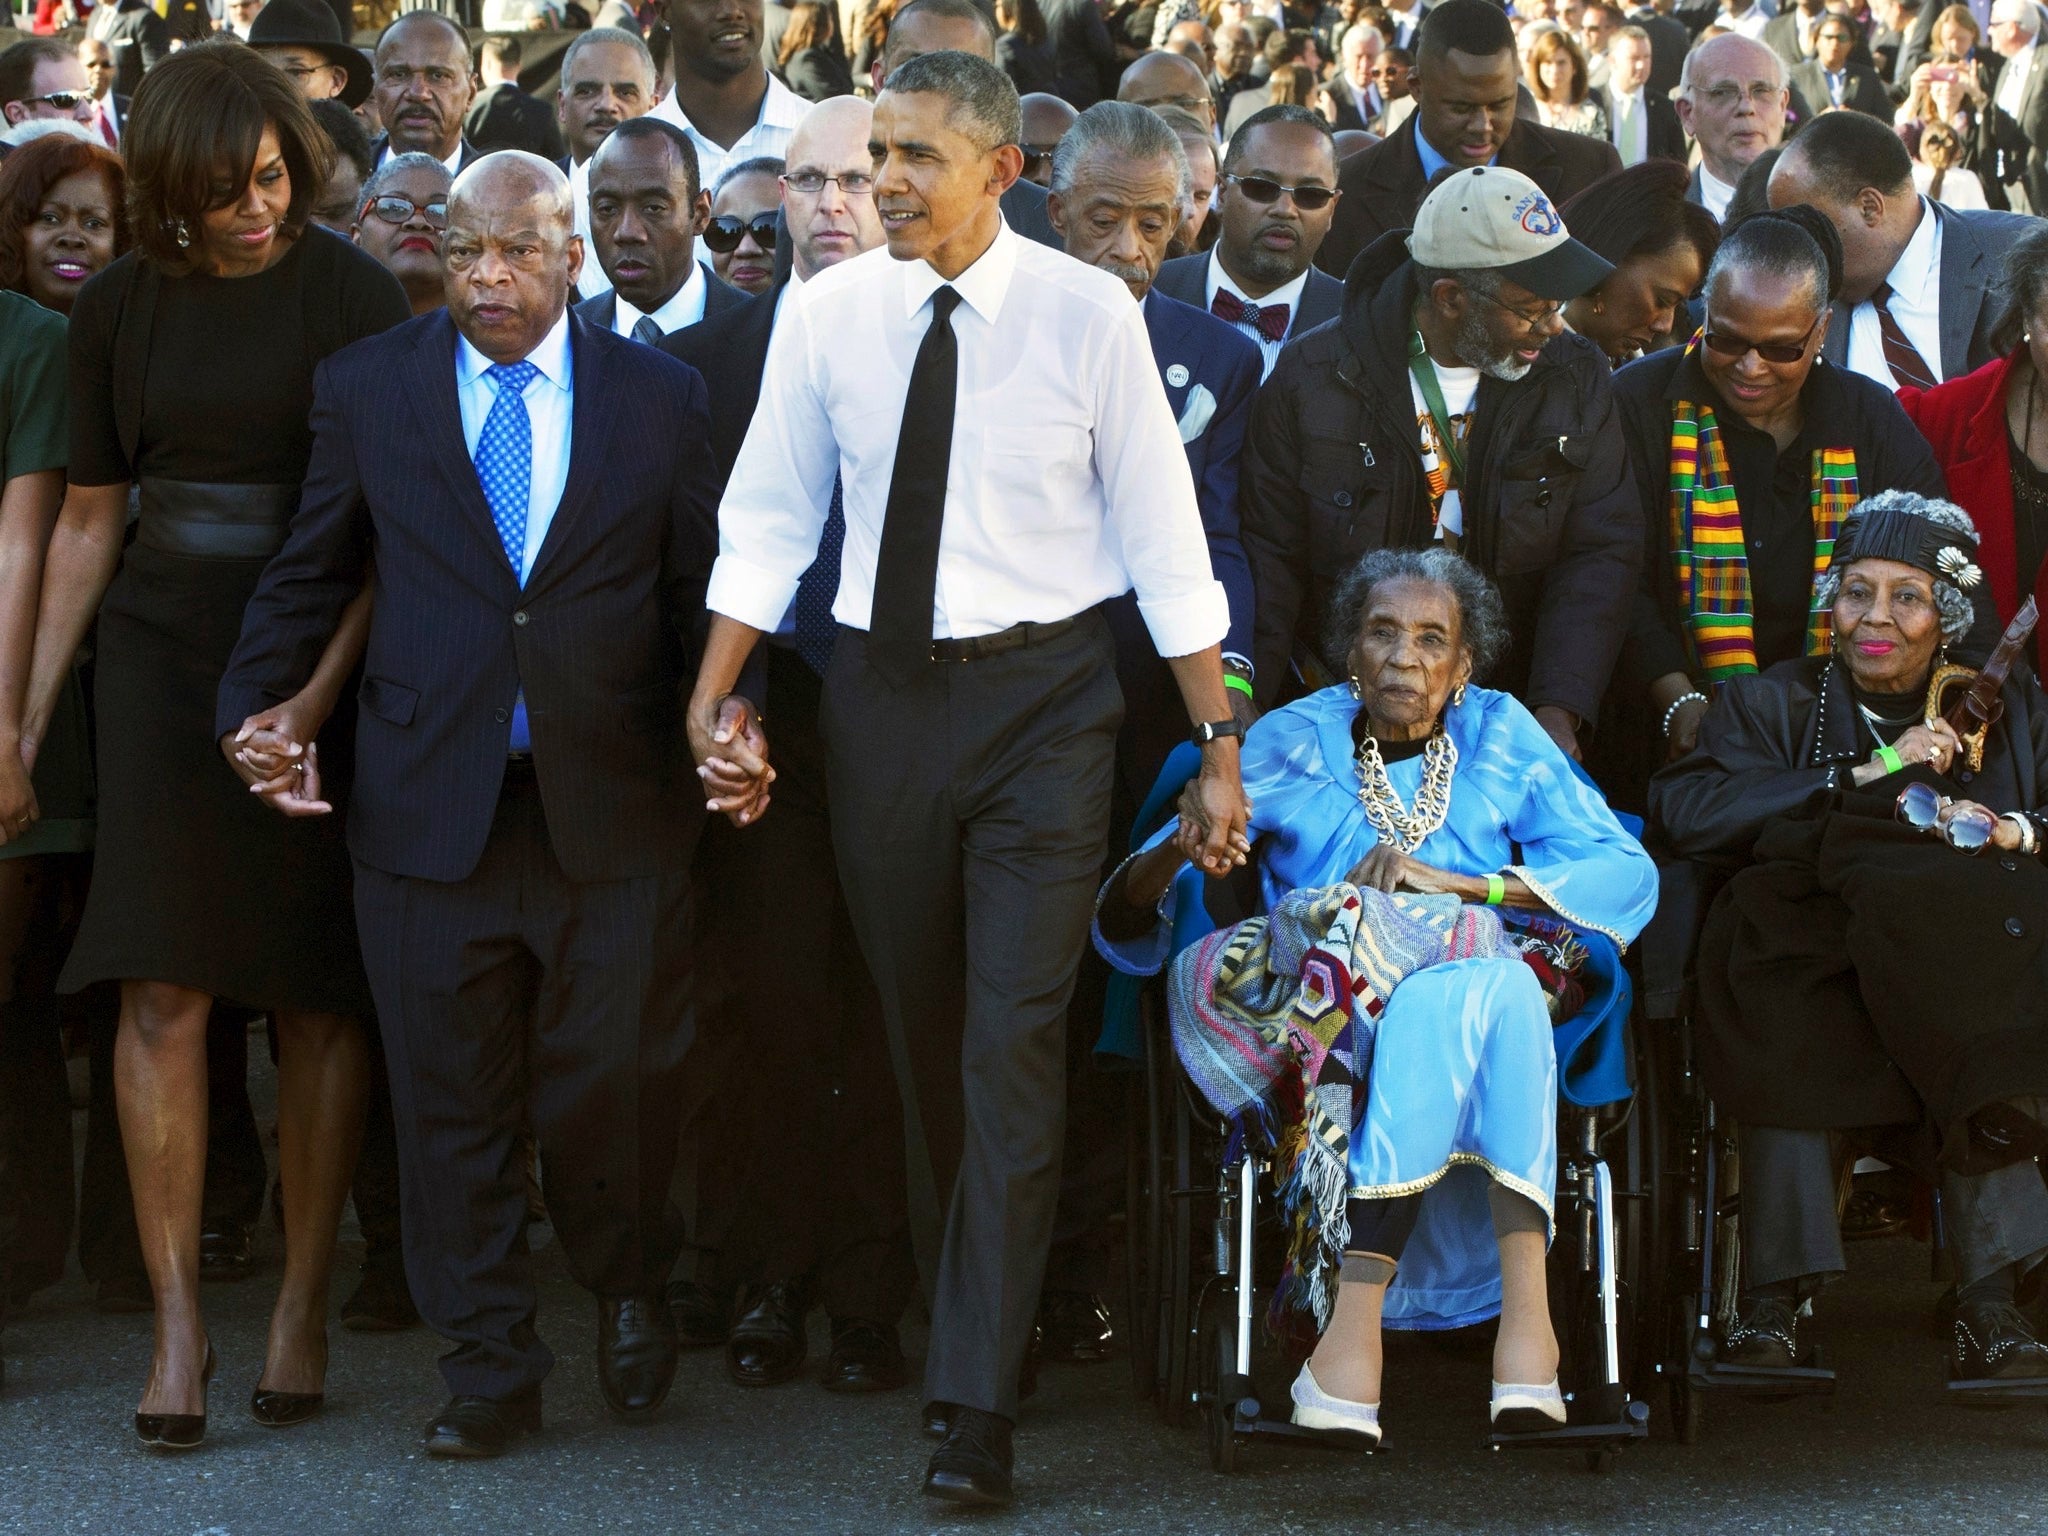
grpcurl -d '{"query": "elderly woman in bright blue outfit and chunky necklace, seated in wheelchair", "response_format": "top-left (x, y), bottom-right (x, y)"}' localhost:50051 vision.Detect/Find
top-left (1096, 549), bottom-right (1657, 1444)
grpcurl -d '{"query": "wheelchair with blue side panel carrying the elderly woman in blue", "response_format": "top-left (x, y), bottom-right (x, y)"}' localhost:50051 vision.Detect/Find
top-left (1112, 752), bottom-right (1663, 1473)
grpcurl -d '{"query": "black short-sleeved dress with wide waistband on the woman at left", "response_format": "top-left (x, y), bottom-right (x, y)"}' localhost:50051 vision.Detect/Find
top-left (61, 227), bottom-right (410, 1016)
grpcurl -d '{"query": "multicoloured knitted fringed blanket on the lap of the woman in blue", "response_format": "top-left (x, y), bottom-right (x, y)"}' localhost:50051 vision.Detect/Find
top-left (1167, 885), bottom-right (1513, 1329)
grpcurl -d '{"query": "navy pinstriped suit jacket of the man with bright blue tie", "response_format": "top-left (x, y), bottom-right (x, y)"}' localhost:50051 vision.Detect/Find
top-left (217, 309), bottom-right (719, 881)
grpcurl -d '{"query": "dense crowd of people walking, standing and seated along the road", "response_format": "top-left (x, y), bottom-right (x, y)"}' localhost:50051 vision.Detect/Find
top-left (0, 0), bottom-right (2048, 1505)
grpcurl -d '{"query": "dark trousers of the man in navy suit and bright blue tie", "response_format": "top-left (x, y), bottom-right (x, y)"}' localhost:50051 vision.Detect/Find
top-left (356, 780), bottom-right (688, 1397)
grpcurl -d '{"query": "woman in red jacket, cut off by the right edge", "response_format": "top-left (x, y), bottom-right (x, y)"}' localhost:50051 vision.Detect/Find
top-left (1898, 227), bottom-right (2048, 676)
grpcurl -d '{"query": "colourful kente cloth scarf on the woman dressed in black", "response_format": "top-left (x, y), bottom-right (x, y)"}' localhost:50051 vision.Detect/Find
top-left (1671, 399), bottom-right (1858, 682)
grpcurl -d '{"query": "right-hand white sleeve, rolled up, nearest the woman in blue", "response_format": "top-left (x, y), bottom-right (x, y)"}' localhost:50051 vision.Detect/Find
top-left (1096, 305), bottom-right (1231, 655)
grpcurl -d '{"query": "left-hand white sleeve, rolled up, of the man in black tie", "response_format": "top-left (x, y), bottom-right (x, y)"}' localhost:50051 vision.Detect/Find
top-left (705, 293), bottom-right (840, 633)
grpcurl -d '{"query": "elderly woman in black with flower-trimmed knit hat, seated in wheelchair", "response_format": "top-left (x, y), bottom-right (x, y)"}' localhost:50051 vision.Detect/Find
top-left (1651, 492), bottom-right (2048, 1380)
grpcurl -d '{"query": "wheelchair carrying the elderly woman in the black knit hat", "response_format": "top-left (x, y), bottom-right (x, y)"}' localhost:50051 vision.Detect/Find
top-left (1638, 862), bottom-right (2048, 1446)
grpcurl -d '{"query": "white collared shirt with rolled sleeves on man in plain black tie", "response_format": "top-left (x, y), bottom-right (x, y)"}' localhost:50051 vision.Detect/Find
top-left (707, 223), bottom-right (1229, 655)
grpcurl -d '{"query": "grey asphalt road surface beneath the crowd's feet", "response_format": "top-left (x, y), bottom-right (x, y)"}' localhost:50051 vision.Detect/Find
top-left (0, 1146), bottom-right (2048, 1536)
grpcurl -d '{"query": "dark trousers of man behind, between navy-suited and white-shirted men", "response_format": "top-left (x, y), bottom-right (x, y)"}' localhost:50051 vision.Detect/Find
top-left (684, 645), bottom-right (915, 1325)
